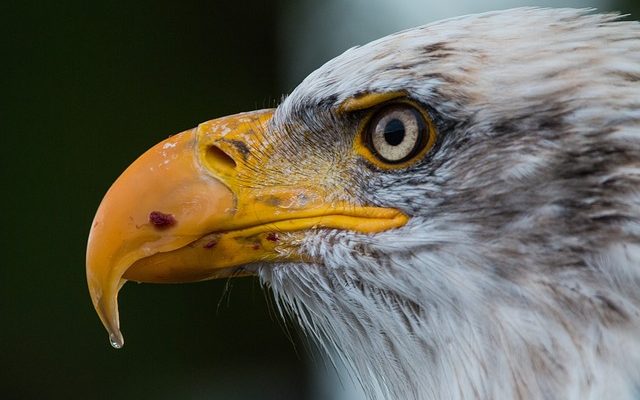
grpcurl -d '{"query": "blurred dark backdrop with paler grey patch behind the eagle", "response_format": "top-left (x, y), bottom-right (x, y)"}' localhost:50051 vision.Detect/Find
top-left (0, 0), bottom-right (640, 399)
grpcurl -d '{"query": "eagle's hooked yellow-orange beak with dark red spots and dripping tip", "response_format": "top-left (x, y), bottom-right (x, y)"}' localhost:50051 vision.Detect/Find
top-left (87, 110), bottom-right (407, 348)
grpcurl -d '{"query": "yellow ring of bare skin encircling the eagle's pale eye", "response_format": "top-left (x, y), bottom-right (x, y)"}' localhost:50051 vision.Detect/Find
top-left (353, 96), bottom-right (437, 170)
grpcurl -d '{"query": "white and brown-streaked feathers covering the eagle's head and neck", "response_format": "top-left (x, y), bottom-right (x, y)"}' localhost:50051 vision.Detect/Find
top-left (259, 8), bottom-right (640, 399)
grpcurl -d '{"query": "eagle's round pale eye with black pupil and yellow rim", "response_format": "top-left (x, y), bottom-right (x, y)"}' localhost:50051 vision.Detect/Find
top-left (360, 102), bottom-right (435, 168)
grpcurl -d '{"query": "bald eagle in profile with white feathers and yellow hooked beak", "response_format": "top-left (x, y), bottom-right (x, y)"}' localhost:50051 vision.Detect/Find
top-left (87, 8), bottom-right (640, 399)
